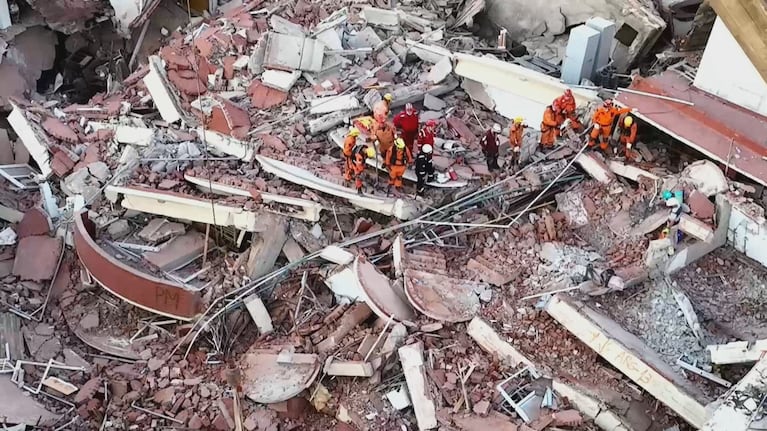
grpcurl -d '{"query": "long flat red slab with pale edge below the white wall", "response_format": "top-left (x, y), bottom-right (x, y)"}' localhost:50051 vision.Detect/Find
top-left (616, 71), bottom-right (767, 185)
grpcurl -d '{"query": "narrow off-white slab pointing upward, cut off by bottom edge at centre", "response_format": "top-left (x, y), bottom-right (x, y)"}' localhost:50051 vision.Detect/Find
top-left (398, 341), bottom-right (437, 431)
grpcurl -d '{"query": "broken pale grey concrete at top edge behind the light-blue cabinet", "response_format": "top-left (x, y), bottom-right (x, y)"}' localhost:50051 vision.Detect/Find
top-left (487, 0), bottom-right (666, 69)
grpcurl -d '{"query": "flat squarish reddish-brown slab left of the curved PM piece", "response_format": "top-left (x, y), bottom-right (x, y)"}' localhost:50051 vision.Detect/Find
top-left (13, 235), bottom-right (63, 281)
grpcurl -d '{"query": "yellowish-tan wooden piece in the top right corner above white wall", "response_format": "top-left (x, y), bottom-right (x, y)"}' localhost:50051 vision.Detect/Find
top-left (711, 0), bottom-right (767, 82)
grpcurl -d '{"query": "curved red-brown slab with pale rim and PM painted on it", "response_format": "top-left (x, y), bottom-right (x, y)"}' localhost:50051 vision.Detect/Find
top-left (74, 211), bottom-right (203, 320)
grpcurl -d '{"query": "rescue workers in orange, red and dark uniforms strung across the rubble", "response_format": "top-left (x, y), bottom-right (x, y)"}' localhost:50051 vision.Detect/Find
top-left (343, 89), bottom-right (637, 195)
